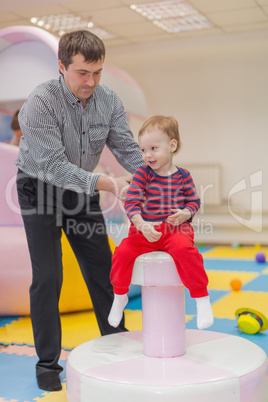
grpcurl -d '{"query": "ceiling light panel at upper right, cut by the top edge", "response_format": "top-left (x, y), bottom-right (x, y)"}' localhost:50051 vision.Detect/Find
top-left (130, 0), bottom-right (212, 33)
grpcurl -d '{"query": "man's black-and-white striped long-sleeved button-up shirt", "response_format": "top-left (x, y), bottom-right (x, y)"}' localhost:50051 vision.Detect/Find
top-left (16, 76), bottom-right (144, 195)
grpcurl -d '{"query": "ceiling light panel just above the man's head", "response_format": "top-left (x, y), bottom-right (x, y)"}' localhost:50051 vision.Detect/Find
top-left (30, 14), bottom-right (115, 40)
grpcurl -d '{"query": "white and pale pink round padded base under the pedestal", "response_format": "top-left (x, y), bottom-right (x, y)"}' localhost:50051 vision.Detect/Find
top-left (66, 330), bottom-right (267, 402)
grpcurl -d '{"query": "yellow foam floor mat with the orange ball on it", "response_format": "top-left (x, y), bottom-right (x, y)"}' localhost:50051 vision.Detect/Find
top-left (206, 270), bottom-right (259, 290)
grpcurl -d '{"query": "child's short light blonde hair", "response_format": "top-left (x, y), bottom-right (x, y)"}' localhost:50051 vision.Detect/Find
top-left (138, 115), bottom-right (181, 153)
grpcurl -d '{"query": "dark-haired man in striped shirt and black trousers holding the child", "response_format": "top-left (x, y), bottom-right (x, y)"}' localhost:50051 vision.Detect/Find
top-left (16, 30), bottom-right (142, 391)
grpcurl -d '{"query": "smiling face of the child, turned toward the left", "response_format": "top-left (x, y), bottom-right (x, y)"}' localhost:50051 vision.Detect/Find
top-left (139, 130), bottom-right (177, 175)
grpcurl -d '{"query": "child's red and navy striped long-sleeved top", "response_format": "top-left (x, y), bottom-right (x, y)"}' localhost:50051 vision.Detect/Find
top-left (125, 165), bottom-right (200, 221)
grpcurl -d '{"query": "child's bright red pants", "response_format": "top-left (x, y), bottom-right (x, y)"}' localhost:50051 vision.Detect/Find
top-left (111, 222), bottom-right (208, 297)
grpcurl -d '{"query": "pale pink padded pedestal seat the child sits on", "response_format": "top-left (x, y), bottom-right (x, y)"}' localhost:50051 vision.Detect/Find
top-left (131, 252), bottom-right (186, 357)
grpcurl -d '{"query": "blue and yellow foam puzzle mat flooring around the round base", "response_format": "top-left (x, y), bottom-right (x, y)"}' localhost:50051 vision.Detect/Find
top-left (0, 246), bottom-right (268, 402)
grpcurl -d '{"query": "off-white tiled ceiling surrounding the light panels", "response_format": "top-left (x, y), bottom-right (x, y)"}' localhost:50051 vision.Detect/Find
top-left (0, 0), bottom-right (268, 47)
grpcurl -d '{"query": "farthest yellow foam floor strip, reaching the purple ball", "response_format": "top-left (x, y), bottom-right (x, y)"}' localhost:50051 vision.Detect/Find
top-left (202, 246), bottom-right (268, 260)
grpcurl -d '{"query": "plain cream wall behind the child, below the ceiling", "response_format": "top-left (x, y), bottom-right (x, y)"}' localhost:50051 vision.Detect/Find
top-left (106, 31), bottom-right (268, 210)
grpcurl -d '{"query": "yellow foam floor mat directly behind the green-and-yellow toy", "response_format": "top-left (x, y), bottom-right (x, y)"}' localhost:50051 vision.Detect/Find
top-left (212, 291), bottom-right (268, 320)
